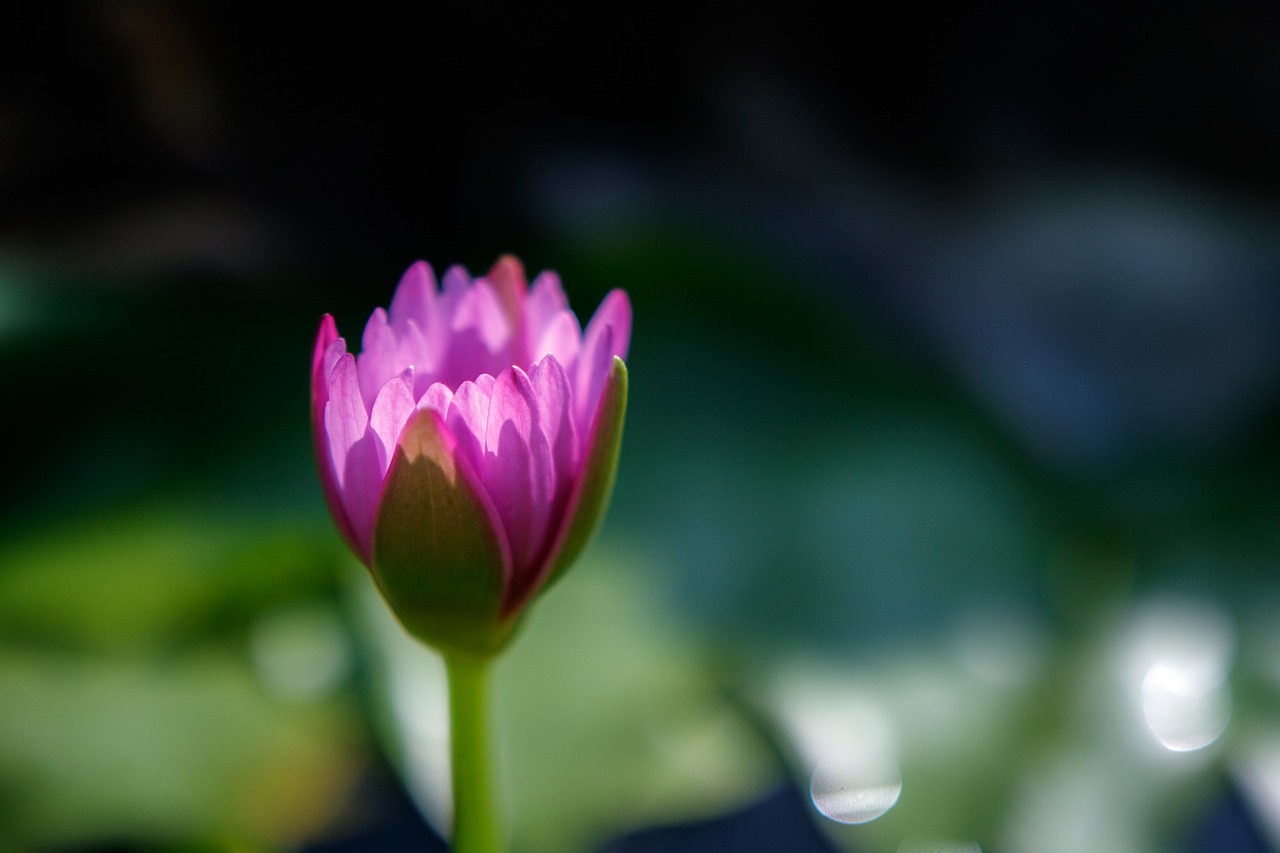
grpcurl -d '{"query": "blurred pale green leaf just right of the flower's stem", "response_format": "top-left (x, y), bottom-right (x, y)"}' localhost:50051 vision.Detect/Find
top-left (499, 542), bottom-right (777, 853)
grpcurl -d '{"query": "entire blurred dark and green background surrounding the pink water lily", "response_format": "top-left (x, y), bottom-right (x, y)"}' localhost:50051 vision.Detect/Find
top-left (0, 0), bottom-right (1280, 853)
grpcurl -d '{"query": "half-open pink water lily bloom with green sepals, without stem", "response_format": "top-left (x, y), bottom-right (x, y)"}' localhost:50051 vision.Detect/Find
top-left (311, 256), bottom-right (631, 654)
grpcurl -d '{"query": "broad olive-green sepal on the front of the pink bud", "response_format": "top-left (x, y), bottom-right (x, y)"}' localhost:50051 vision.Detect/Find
top-left (372, 409), bottom-right (511, 657)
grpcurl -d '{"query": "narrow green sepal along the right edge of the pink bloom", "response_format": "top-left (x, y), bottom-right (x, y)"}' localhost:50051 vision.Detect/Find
top-left (516, 356), bottom-right (627, 607)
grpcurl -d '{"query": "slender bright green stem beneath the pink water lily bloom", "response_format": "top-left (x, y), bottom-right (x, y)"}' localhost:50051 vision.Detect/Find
top-left (444, 654), bottom-right (503, 853)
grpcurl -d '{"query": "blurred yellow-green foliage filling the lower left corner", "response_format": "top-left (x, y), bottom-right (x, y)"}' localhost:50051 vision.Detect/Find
top-left (0, 505), bottom-right (366, 849)
